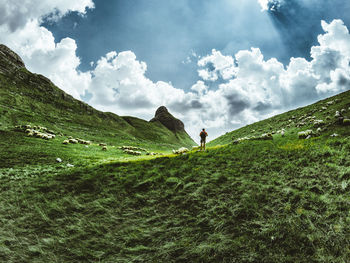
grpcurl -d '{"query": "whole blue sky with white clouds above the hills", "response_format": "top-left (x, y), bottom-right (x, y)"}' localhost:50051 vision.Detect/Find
top-left (0, 0), bottom-right (350, 141)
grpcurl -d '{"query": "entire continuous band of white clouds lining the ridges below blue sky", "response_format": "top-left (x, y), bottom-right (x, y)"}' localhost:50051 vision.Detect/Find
top-left (0, 0), bottom-right (350, 143)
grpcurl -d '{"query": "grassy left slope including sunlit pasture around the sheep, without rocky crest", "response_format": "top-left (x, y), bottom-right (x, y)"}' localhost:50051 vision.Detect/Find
top-left (0, 68), bottom-right (195, 167)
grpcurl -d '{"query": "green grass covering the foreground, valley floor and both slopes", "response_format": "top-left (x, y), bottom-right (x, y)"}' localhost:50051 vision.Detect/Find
top-left (0, 49), bottom-right (350, 263)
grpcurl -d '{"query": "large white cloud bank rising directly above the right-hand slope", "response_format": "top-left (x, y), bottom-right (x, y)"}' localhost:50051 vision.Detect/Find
top-left (192, 20), bottom-right (350, 140)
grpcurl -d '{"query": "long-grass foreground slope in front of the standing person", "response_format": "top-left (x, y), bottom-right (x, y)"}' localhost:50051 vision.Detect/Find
top-left (0, 93), bottom-right (350, 263)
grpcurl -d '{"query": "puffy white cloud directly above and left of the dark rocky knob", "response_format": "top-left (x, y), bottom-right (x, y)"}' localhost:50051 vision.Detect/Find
top-left (89, 51), bottom-right (192, 118)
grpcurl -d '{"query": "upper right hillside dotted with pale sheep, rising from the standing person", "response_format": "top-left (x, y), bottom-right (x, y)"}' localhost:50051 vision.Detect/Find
top-left (208, 91), bottom-right (350, 146)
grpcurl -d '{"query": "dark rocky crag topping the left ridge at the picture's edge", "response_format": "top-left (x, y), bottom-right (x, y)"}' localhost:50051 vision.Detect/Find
top-left (0, 44), bottom-right (25, 74)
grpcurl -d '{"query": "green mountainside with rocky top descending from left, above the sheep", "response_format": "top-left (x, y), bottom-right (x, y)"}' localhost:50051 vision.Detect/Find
top-left (0, 45), bottom-right (196, 149)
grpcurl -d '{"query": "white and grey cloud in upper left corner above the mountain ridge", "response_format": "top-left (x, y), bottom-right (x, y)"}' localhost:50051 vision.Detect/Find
top-left (0, 0), bottom-right (94, 98)
